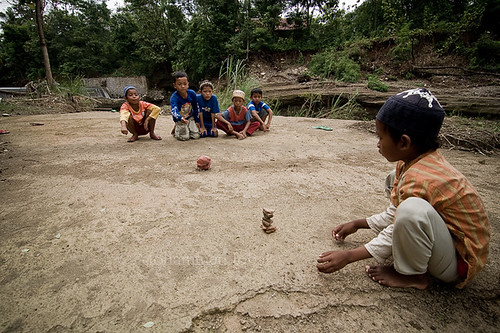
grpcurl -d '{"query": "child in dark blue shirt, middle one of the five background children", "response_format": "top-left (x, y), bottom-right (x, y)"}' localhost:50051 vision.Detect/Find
top-left (196, 80), bottom-right (220, 138)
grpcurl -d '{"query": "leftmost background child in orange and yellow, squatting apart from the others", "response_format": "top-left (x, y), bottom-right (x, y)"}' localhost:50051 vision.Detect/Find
top-left (120, 86), bottom-right (161, 142)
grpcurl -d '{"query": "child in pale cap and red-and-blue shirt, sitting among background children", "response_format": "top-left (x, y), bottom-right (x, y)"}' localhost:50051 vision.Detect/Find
top-left (216, 90), bottom-right (260, 140)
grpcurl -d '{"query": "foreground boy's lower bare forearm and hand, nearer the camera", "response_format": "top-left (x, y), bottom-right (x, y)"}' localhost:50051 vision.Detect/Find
top-left (316, 246), bottom-right (372, 273)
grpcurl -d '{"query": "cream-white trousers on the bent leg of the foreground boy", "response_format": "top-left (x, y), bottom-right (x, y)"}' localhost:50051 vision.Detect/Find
top-left (392, 197), bottom-right (459, 282)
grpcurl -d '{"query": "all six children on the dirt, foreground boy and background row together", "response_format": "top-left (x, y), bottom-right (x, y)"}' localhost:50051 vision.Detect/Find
top-left (120, 72), bottom-right (490, 289)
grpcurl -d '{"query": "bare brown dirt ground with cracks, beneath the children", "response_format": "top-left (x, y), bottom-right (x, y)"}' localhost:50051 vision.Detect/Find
top-left (0, 112), bottom-right (500, 332)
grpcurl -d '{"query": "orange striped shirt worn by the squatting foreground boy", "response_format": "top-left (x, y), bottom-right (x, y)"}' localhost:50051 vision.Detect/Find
top-left (391, 150), bottom-right (490, 288)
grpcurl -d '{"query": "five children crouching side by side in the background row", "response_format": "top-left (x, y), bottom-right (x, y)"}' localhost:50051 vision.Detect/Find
top-left (120, 71), bottom-right (273, 142)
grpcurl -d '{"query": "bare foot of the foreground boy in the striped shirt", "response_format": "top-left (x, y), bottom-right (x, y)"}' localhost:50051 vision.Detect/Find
top-left (365, 265), bottom-right (429, 290)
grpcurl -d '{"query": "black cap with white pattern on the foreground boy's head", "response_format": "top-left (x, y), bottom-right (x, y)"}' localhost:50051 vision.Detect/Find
top-left (377, 88), bottom-right (445, 138)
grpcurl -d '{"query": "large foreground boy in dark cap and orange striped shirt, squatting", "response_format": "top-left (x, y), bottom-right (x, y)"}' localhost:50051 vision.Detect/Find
top-left (317, 89), bottom-right (490, 289)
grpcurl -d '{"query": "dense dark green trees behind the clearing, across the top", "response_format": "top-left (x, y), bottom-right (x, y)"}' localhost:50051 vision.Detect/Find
top-left (0, 0), bottom-right (500, 85)
